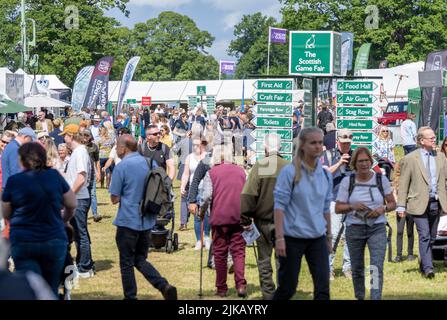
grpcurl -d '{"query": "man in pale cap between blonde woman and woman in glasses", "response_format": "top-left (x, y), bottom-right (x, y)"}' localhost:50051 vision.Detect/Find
top-left (323, 129), bottom-right (352, 280)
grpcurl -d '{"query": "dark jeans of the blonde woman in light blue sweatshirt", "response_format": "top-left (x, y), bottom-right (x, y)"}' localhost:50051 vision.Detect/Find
top-left (273, 236), bottom-right (330, 300)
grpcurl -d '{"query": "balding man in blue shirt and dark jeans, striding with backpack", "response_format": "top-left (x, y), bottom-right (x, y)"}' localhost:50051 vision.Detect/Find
top-left (110, 134), bottom-right (177, 300)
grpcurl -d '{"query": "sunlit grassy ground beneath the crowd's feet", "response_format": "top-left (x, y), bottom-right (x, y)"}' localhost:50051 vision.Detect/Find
top-left (72, 149), bottom-right (447, 299)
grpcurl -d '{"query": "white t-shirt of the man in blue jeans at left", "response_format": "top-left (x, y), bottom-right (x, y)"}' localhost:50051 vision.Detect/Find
top-left (65, 145), bottom-right (90, 199)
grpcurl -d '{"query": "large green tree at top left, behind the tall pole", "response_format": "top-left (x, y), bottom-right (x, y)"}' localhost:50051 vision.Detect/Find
top-left (0, 0), bottom-right (129, 86)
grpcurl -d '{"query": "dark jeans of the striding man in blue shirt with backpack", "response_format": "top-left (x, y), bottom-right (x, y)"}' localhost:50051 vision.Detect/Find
top-left (115, 227), bottom-right (168, 300)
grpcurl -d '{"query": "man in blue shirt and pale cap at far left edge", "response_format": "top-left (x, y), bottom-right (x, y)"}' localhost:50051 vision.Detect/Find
top-left (2, 127), bottom-right (37, 189)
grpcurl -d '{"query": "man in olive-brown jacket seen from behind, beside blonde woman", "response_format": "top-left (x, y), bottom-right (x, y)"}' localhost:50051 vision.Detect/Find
top-left (241, 133), bottom-right (289, 300)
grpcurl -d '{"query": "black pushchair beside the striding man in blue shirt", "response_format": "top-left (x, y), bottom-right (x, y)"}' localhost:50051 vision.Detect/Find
top-left (151, 190), bottom-right (178, 253)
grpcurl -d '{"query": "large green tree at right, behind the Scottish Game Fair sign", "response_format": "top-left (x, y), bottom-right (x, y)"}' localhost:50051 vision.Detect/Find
top-left (281, 0), bottom-right (447, 67)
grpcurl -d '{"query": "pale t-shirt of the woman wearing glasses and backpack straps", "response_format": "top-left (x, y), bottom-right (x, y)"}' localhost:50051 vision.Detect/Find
top-left (337, 174), bottom-right (393, 226)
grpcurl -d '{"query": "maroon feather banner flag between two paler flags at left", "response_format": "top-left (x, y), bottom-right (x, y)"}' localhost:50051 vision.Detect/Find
top-left (84, 57), bottom-right (114, 109)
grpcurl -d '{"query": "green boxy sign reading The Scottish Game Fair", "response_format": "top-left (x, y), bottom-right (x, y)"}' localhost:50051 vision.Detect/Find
top-left (289, 31), bottom-right (341, 76)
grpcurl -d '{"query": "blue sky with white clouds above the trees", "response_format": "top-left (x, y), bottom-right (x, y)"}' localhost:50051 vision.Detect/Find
top-left (106, 0), bottom-right (281, 61)
